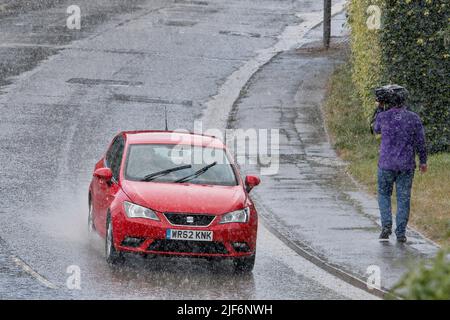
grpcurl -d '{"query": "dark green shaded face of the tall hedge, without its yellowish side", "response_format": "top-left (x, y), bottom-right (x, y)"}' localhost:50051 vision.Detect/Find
top-left (380, 0), bottom-right (450, 152)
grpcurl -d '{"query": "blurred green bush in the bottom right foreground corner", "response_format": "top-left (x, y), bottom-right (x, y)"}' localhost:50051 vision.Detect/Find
top-left (393, 249), bottom-right (450, 300)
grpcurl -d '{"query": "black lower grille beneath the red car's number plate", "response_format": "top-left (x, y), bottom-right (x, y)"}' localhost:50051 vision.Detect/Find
top-left (147, 240), bottom-right (228, 254)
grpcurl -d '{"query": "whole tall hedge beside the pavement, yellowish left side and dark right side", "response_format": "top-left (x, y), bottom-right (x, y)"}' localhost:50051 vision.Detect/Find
top-left (348, 0), bottom-right (450, 152)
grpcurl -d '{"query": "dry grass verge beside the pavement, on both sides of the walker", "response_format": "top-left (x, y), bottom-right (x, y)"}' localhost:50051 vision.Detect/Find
top-left (324, 63), bottom-right (450, 245)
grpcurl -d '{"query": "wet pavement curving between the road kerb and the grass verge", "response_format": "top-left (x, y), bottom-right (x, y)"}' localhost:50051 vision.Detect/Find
top-left (228, 14), bottom-right (438, 290)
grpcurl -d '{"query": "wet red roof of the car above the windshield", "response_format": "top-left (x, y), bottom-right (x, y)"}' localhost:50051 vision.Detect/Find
top-left (121, 130), bottom-right (225, 149)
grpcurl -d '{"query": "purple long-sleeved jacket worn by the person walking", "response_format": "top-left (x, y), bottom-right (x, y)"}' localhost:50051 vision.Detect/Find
top-left (374, 107), bottom-right (427, 171)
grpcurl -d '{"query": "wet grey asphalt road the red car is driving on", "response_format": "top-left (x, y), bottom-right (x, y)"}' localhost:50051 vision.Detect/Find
top-left (0, 0), bottom-right (372, 299)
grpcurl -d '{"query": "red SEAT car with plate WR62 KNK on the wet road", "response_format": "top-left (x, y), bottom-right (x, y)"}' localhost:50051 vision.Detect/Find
top-left (88, 131), bottom-right (260, 272)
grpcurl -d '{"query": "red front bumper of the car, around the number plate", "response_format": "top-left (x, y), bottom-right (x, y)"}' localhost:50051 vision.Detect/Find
top-left (113, 212), bottom-right (257, 258)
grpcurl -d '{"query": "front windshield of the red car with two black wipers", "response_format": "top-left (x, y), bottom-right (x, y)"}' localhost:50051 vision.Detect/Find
top-left (125, 144), bottom-right (238, 186)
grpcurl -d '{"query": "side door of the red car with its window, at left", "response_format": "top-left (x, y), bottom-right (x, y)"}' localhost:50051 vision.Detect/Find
top-left (94, 136), bottom-right (125, 234)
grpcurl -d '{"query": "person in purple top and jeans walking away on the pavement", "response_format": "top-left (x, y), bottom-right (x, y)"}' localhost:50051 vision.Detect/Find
top-left (373, 85), bottom-right (428, 243)
